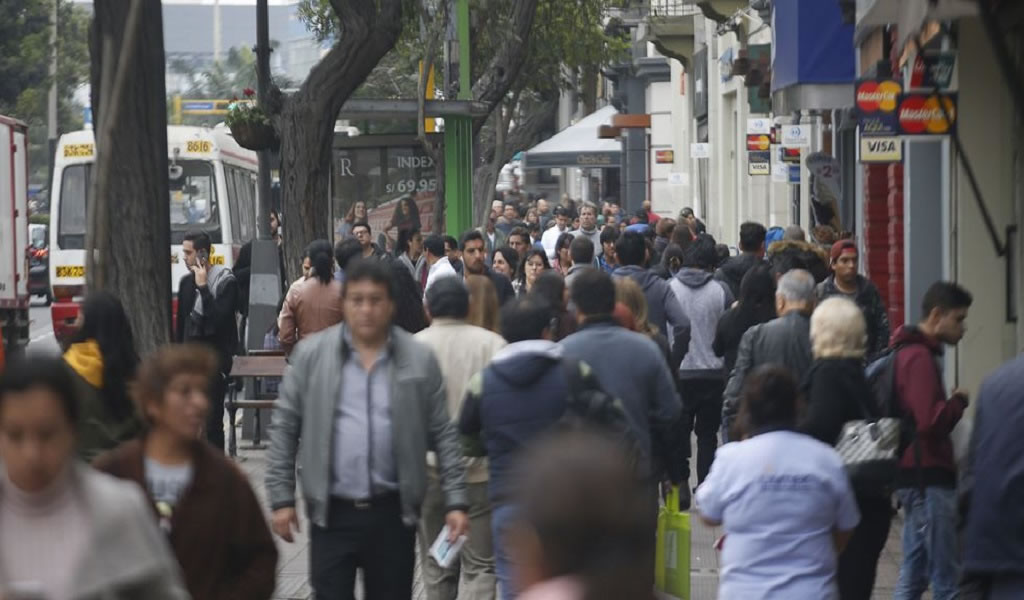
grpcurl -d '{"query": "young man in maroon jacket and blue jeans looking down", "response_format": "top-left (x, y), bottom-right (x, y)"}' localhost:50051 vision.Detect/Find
top-left (891, 282), bottom-right (973, 600)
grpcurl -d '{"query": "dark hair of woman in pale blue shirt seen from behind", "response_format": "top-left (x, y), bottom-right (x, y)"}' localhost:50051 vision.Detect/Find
top-left (739, 363), bottom-right (800, 435)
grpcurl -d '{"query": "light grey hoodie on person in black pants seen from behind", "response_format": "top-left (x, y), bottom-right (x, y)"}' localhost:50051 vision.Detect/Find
top-left (670, 267), bottom-right (735, 379)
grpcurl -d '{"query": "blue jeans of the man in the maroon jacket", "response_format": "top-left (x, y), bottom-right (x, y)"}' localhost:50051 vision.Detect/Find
top-left (893, 486), bottom-right (961, 600)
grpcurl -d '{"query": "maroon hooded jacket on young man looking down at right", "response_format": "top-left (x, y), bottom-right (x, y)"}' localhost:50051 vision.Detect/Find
top-left (892, 326), bottom-right (967, 487)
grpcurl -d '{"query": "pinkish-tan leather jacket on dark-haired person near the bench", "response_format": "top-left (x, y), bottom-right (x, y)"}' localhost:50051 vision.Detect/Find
top-left (278, 277), bottom-right (344, 354)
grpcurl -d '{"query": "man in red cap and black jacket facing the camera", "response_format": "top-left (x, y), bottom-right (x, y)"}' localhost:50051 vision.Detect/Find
top-left (817, 240), bottom-right (889, 361)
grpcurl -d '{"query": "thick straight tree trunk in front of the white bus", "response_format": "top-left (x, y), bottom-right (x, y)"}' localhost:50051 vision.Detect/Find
top-left (86, 0), bottom-right (171, 354)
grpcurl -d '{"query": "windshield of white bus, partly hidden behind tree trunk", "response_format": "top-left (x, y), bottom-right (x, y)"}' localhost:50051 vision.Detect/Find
top-left (57, 160), bottom-right (220, 250)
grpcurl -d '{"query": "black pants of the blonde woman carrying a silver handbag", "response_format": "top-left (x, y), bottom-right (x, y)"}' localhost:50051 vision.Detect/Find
top-left (839, 497), bottom-right (893, 600)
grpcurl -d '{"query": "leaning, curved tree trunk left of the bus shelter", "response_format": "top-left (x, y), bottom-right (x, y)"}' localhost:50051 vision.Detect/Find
top-left (278, 0), bottom-right (403, 282)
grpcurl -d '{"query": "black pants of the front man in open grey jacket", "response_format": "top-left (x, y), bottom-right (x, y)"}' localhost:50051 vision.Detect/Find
top-left (309, 494), bottom-right (415, 600)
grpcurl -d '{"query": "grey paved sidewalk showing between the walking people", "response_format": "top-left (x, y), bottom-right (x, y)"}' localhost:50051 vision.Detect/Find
top-left (239, 444), bottom-right (931, 600)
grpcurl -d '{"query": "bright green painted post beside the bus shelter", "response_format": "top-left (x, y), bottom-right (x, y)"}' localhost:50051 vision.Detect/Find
top-left (444, 0), bottom-right (473, 237)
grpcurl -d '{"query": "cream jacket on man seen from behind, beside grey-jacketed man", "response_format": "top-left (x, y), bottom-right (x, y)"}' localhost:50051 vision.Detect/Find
top-left (416, 318), bottom-right (505, 483)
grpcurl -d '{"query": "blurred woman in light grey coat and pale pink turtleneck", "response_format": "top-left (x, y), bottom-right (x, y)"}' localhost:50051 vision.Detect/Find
top-left (0, 356), bottom-right (188, 600)
